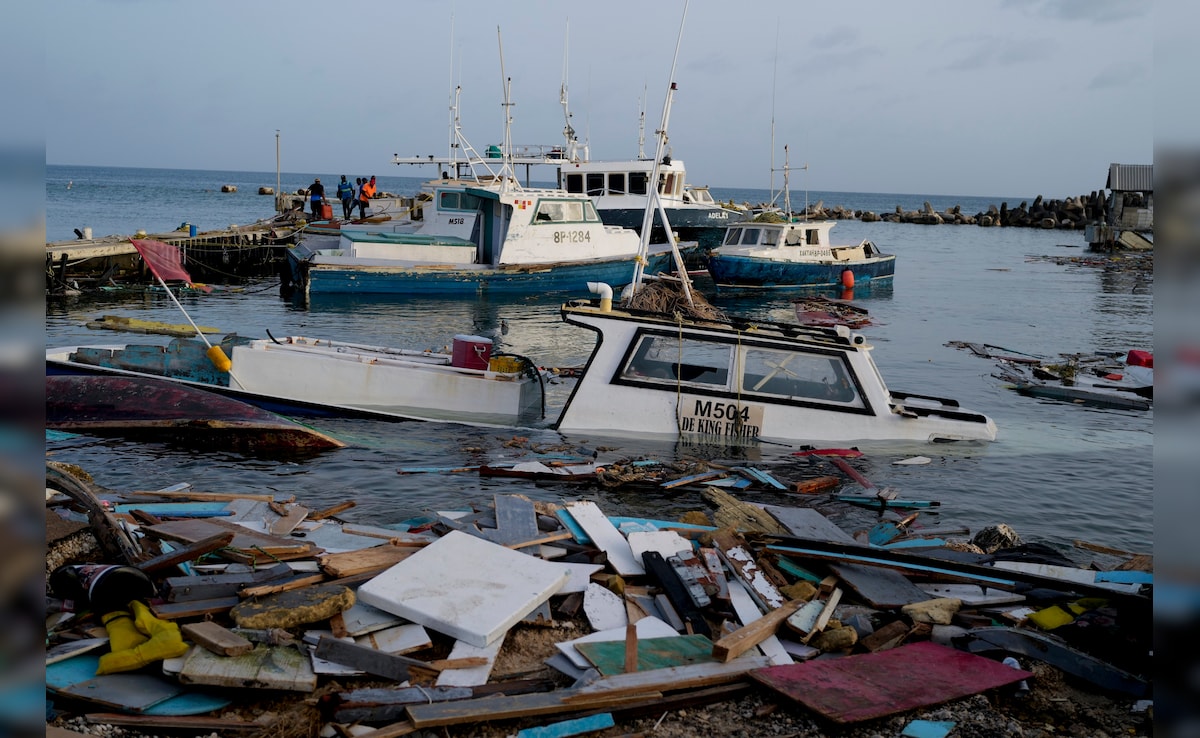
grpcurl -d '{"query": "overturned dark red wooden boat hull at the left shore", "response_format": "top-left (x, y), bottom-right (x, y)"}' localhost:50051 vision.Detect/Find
top-left (46, 374), bottom-right (346, 452)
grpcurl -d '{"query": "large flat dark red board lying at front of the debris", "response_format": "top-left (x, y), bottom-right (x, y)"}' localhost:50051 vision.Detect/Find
top-left (750, 641), bottom-right (1033, 724)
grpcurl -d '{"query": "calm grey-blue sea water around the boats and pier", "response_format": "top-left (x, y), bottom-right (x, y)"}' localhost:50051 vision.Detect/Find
top-left (46, 167), bottom-right (1153, 563)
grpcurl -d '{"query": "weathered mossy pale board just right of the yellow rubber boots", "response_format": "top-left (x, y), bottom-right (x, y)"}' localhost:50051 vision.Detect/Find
top-left (179, 643), bottom-right (317, 691)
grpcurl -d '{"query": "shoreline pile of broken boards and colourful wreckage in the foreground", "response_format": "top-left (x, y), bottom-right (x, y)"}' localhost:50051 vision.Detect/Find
top-left (47, 462), bottom-right (1152, 738)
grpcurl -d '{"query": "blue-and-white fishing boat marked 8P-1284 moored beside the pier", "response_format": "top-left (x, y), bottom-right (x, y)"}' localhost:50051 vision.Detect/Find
top-left (288, 179), bottom-right (691, 295)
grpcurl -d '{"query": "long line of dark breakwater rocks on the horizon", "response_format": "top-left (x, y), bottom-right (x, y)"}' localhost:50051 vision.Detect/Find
top-left (805, 192), bottom-right (1108, 229)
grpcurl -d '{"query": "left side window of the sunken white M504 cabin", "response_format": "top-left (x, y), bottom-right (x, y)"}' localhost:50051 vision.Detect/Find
top-left (620, 336), bottom-right (733, 389)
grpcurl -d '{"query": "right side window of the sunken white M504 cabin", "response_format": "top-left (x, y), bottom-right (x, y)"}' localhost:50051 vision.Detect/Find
top-left (742, 348), bottom-right (864, 407)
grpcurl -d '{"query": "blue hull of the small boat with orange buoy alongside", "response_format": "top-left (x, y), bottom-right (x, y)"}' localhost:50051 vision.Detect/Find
top-left (708, 253), bottom-right (895, 289)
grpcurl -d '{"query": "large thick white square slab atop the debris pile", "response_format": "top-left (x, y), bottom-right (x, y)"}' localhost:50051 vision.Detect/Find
top-left (359, 530), bottom-right (569, 648)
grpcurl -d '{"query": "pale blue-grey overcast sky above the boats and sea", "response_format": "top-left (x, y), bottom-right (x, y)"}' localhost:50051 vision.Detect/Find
top-left (44, 0), bottom-right (1154, 197)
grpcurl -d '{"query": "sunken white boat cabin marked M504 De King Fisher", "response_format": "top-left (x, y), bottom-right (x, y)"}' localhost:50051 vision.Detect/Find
top-left (557, 286), bottom-right (996, 444)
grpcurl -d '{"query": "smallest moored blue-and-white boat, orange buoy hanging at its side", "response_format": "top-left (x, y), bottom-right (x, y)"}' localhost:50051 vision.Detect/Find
top-left (707, 146), bottom-right (896, 290)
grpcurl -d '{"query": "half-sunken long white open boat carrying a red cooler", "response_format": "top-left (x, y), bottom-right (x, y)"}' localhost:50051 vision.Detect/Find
top-left (46, 335), bottom-right (544, 426)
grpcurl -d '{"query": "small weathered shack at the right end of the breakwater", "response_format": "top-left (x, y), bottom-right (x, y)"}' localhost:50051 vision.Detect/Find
top-left (1085, 164), bottom-right (1154, 250)
